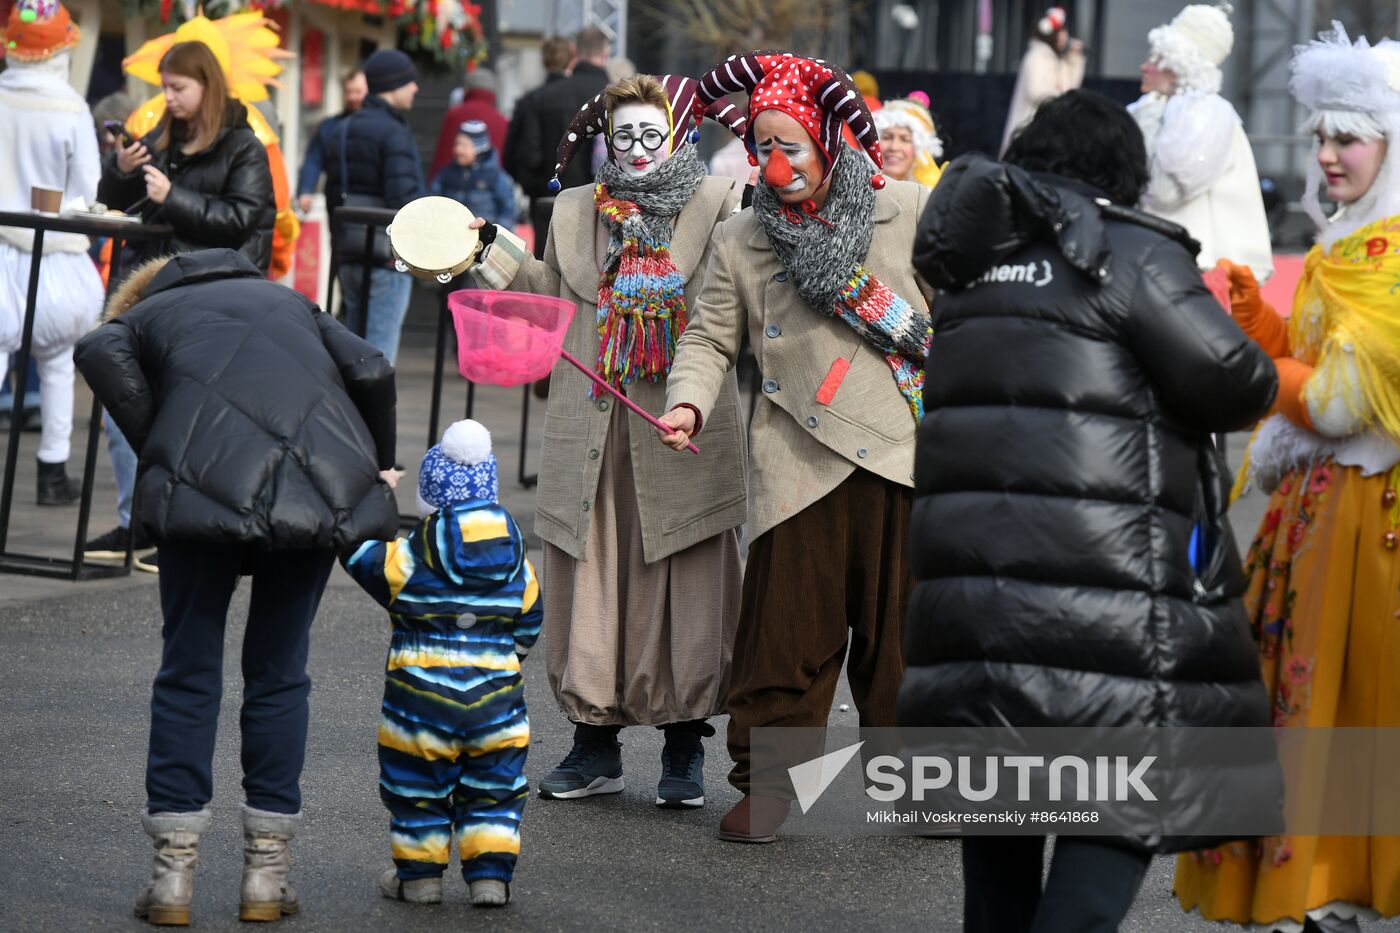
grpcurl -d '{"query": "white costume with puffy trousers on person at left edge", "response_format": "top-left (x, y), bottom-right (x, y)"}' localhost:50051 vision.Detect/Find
top-left (0, 52), bottom-right (102, 464)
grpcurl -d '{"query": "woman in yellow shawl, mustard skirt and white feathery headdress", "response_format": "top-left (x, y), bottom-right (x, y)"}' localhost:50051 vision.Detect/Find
top-left (1176, 22), bottom-right (1400, 933)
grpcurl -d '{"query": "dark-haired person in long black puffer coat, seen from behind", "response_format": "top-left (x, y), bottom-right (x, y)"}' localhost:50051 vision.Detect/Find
top-left (899, 91), bottom-right (1277, 930)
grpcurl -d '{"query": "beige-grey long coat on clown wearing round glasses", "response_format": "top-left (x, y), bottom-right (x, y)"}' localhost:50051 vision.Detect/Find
top-left (510, 178), bottom-right (746, 563)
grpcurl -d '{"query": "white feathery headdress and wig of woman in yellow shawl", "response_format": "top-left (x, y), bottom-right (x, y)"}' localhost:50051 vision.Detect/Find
top-left (1288, 21), bottom-right (1400, 249)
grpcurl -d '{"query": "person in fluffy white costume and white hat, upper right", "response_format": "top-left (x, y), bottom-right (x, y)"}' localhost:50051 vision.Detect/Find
top-left (1128, 4), bottom-right (1274, 282)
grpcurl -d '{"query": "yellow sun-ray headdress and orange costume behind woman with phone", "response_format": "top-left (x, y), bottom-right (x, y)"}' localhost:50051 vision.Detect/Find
top-left (122, 11), bottom-right (301, 279)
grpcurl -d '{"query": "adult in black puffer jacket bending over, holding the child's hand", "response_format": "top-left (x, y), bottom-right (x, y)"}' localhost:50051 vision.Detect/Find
top-left (77, 249), bottom-right (399, 923)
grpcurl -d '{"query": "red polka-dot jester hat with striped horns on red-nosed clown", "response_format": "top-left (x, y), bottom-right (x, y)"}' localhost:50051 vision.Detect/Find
top-left (700, 52), bottom-right (885, 188)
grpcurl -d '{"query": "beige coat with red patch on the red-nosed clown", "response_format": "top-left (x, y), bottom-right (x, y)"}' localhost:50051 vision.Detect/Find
top-left (663, 181), bottom-right (930, 538)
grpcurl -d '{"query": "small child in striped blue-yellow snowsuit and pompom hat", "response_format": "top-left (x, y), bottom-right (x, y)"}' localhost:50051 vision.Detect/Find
top-left (344, 420), bottom-right (543, 906)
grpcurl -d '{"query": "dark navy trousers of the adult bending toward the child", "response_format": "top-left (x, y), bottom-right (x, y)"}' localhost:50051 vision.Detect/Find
top-left (146, 541), bottom-right (336, 813)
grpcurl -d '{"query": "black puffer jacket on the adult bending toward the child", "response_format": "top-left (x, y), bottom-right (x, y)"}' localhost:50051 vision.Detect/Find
top-left (77, 249), bottom-right (399, 551)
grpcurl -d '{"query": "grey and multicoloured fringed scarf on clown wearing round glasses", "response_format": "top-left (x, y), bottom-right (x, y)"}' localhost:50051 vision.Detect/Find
top-left (594, 146), bottom-right (704, 391)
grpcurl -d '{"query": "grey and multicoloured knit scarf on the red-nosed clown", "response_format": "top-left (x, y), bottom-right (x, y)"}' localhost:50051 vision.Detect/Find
top-left (753, 147), bottom-right (934, 422)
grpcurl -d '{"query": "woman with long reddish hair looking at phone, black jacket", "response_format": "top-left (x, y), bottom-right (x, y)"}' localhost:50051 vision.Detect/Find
top-left (97, 42), bottom-right (277, 273)
